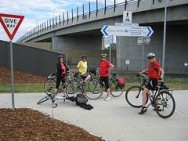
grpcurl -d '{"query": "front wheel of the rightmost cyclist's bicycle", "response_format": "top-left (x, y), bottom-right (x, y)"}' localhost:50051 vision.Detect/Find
top-left (125, 86), bottom-right (145, 108)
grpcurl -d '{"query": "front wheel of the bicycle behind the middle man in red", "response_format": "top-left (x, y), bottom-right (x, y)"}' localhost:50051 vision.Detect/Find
top-left (84, 79), bottom-right (102, 100)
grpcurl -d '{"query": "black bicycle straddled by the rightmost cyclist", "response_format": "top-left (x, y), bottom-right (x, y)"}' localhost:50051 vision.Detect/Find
top-left (125, 74), bottom-right (176, 118)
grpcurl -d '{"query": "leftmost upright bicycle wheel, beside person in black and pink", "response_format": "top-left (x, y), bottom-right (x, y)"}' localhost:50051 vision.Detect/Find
top-left (44, 78), bottom-right (56, 94)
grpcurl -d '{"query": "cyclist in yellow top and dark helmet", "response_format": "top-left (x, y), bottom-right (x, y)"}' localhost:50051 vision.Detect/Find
top-left (77, 55), bottom-right (91, 82)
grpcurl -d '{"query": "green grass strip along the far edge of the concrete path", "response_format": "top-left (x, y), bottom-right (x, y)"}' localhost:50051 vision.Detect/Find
top-left (0, 76), bottom-right (188, 93)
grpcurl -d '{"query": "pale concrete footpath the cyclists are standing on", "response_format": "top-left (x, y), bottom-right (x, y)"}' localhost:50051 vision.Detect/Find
top-left (0, 90), bottom-right (188, 141)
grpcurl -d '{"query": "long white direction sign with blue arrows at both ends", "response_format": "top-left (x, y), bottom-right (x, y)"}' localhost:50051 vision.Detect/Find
top-left (101, 25), bottom-right (153, 37)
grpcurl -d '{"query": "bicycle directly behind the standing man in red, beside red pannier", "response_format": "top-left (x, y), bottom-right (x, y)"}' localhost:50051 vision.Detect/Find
top-left (87, 73), bottom-right (125, 100)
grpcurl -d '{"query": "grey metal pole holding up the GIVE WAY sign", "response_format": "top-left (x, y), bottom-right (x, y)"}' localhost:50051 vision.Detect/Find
top-left (10, 40), bottom-right (15, 110)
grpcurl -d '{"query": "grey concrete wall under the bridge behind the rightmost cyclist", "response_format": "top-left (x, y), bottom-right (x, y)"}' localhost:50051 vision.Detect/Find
top-left (117, 26), bottom-right (188, 73)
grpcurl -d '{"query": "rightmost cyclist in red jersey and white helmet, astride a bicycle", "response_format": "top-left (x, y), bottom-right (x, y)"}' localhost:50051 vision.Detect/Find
top-left (139, 53), bottom-right (164, 115)
